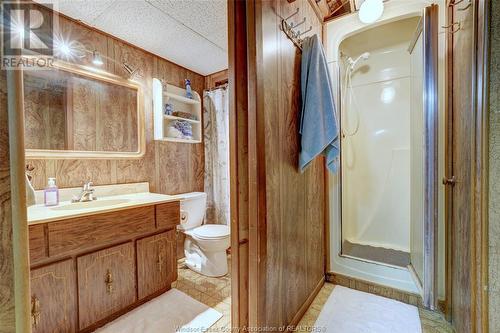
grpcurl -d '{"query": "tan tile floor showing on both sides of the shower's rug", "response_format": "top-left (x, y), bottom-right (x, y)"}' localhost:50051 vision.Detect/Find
top-left (297, 283), bottom-right (454, 333)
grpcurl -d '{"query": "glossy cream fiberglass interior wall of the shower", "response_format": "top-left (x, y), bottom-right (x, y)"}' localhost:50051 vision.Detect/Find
top-left (339, 17), bottom-right (423, 268)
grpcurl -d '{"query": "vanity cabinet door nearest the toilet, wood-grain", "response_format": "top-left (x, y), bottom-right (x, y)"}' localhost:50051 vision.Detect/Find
top-left (137, 230), bottom-right (177, 299)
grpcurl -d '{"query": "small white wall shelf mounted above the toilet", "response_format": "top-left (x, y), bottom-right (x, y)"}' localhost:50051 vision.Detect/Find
top-left (153, 78), bottom-right (203, 143)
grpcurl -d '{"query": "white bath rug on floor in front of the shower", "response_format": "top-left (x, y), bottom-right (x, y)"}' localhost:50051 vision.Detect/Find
top-left (314, 286), bottom-right (422, 333)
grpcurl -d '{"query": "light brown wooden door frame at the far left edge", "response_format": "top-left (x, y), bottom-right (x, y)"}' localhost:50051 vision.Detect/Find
top-left (0, 0), bottom-right (31, 333)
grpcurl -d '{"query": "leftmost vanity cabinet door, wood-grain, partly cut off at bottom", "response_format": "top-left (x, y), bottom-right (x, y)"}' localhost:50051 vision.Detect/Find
top-left (30, 260), bottom-right (76, 333)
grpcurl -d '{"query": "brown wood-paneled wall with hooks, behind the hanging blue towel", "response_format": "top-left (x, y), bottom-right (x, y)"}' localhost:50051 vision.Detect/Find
top-left (255, 0), bottom-right (326, 327)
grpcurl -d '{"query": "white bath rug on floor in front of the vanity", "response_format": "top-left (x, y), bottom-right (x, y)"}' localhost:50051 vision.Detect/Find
top-left (95, 289), bottom-right (222, 333)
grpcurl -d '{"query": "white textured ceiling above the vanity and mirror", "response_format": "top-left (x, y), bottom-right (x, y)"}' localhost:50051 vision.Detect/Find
top-left (40, 0), bottom-right (228, 75)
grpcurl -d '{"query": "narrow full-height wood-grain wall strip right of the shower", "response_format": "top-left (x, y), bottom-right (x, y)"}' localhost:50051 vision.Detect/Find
top-left (447, 0), bottom-right (494, 333)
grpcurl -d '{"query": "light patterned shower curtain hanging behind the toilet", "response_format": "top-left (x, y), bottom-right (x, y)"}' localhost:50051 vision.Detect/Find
top-left (203, 88), bottom-right (229, 225)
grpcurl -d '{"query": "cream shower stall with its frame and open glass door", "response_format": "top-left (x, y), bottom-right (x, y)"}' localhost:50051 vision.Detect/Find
top-left (328, 2), bottom-right (444, 306)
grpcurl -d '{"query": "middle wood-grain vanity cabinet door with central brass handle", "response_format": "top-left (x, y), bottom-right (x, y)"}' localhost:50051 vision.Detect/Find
top-left (77, 242), bottom-right (136, 329)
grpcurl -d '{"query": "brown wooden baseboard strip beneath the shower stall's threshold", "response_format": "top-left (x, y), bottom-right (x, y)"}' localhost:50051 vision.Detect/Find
top-left (325, 272), bottom-right (422, 307)
